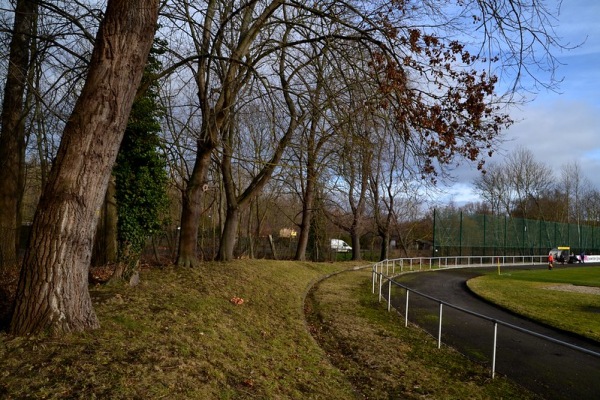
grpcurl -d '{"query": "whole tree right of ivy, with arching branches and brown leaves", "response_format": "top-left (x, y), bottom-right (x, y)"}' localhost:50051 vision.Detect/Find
top-left (166, 0), bottom-right (556, 266)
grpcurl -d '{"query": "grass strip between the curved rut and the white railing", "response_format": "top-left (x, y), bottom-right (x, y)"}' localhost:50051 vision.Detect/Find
top-left (307, 271), bottom-right (536, 399)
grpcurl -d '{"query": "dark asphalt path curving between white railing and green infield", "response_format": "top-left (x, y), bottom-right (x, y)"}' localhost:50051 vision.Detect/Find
top-left (384, 266), bottom-right (600, 400)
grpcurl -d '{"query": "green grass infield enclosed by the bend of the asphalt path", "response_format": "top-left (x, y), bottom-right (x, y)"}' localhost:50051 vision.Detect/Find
top-left (467, 266), bottom-right (600, 341)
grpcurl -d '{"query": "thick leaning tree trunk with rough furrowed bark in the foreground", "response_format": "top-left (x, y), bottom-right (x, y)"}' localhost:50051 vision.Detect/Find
top-left (10, 0), bottom-right (159, 334)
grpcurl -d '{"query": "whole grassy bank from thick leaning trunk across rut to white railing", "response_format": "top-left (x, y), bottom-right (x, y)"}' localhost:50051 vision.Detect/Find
top-left (0, 261), bottom-right (526, 399)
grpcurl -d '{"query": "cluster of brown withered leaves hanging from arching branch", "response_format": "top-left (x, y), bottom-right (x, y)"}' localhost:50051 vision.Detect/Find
top-left (370, 29), bottom-right (513, 181)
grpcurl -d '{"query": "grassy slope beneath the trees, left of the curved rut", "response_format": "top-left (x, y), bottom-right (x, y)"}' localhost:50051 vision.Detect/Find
top-left (0, 261), bottom-right (352, 399)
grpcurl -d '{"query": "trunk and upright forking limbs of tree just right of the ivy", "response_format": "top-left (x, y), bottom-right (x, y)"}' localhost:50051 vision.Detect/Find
top-left (171, 0), bottom-right (283, 267)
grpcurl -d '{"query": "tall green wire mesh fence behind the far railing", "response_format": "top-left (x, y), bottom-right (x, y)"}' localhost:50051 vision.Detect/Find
top-left (433, 211), bottom-right (600, 256)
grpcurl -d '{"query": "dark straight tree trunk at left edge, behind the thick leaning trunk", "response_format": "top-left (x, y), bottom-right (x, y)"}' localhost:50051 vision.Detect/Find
top-left (0, 0), bottom-right (37, 268)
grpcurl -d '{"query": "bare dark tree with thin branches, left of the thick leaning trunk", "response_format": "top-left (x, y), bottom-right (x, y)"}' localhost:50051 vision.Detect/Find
top-left (0, 0), bottom-right (102, 272)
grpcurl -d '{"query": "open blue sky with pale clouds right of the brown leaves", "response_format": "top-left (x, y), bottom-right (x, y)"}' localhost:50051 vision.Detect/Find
top-left (438, 0), bottom-right (600, 205)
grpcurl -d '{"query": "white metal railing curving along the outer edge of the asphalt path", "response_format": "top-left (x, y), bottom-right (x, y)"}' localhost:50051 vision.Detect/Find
top-left (372, 255), bottom-right (600, 378)
